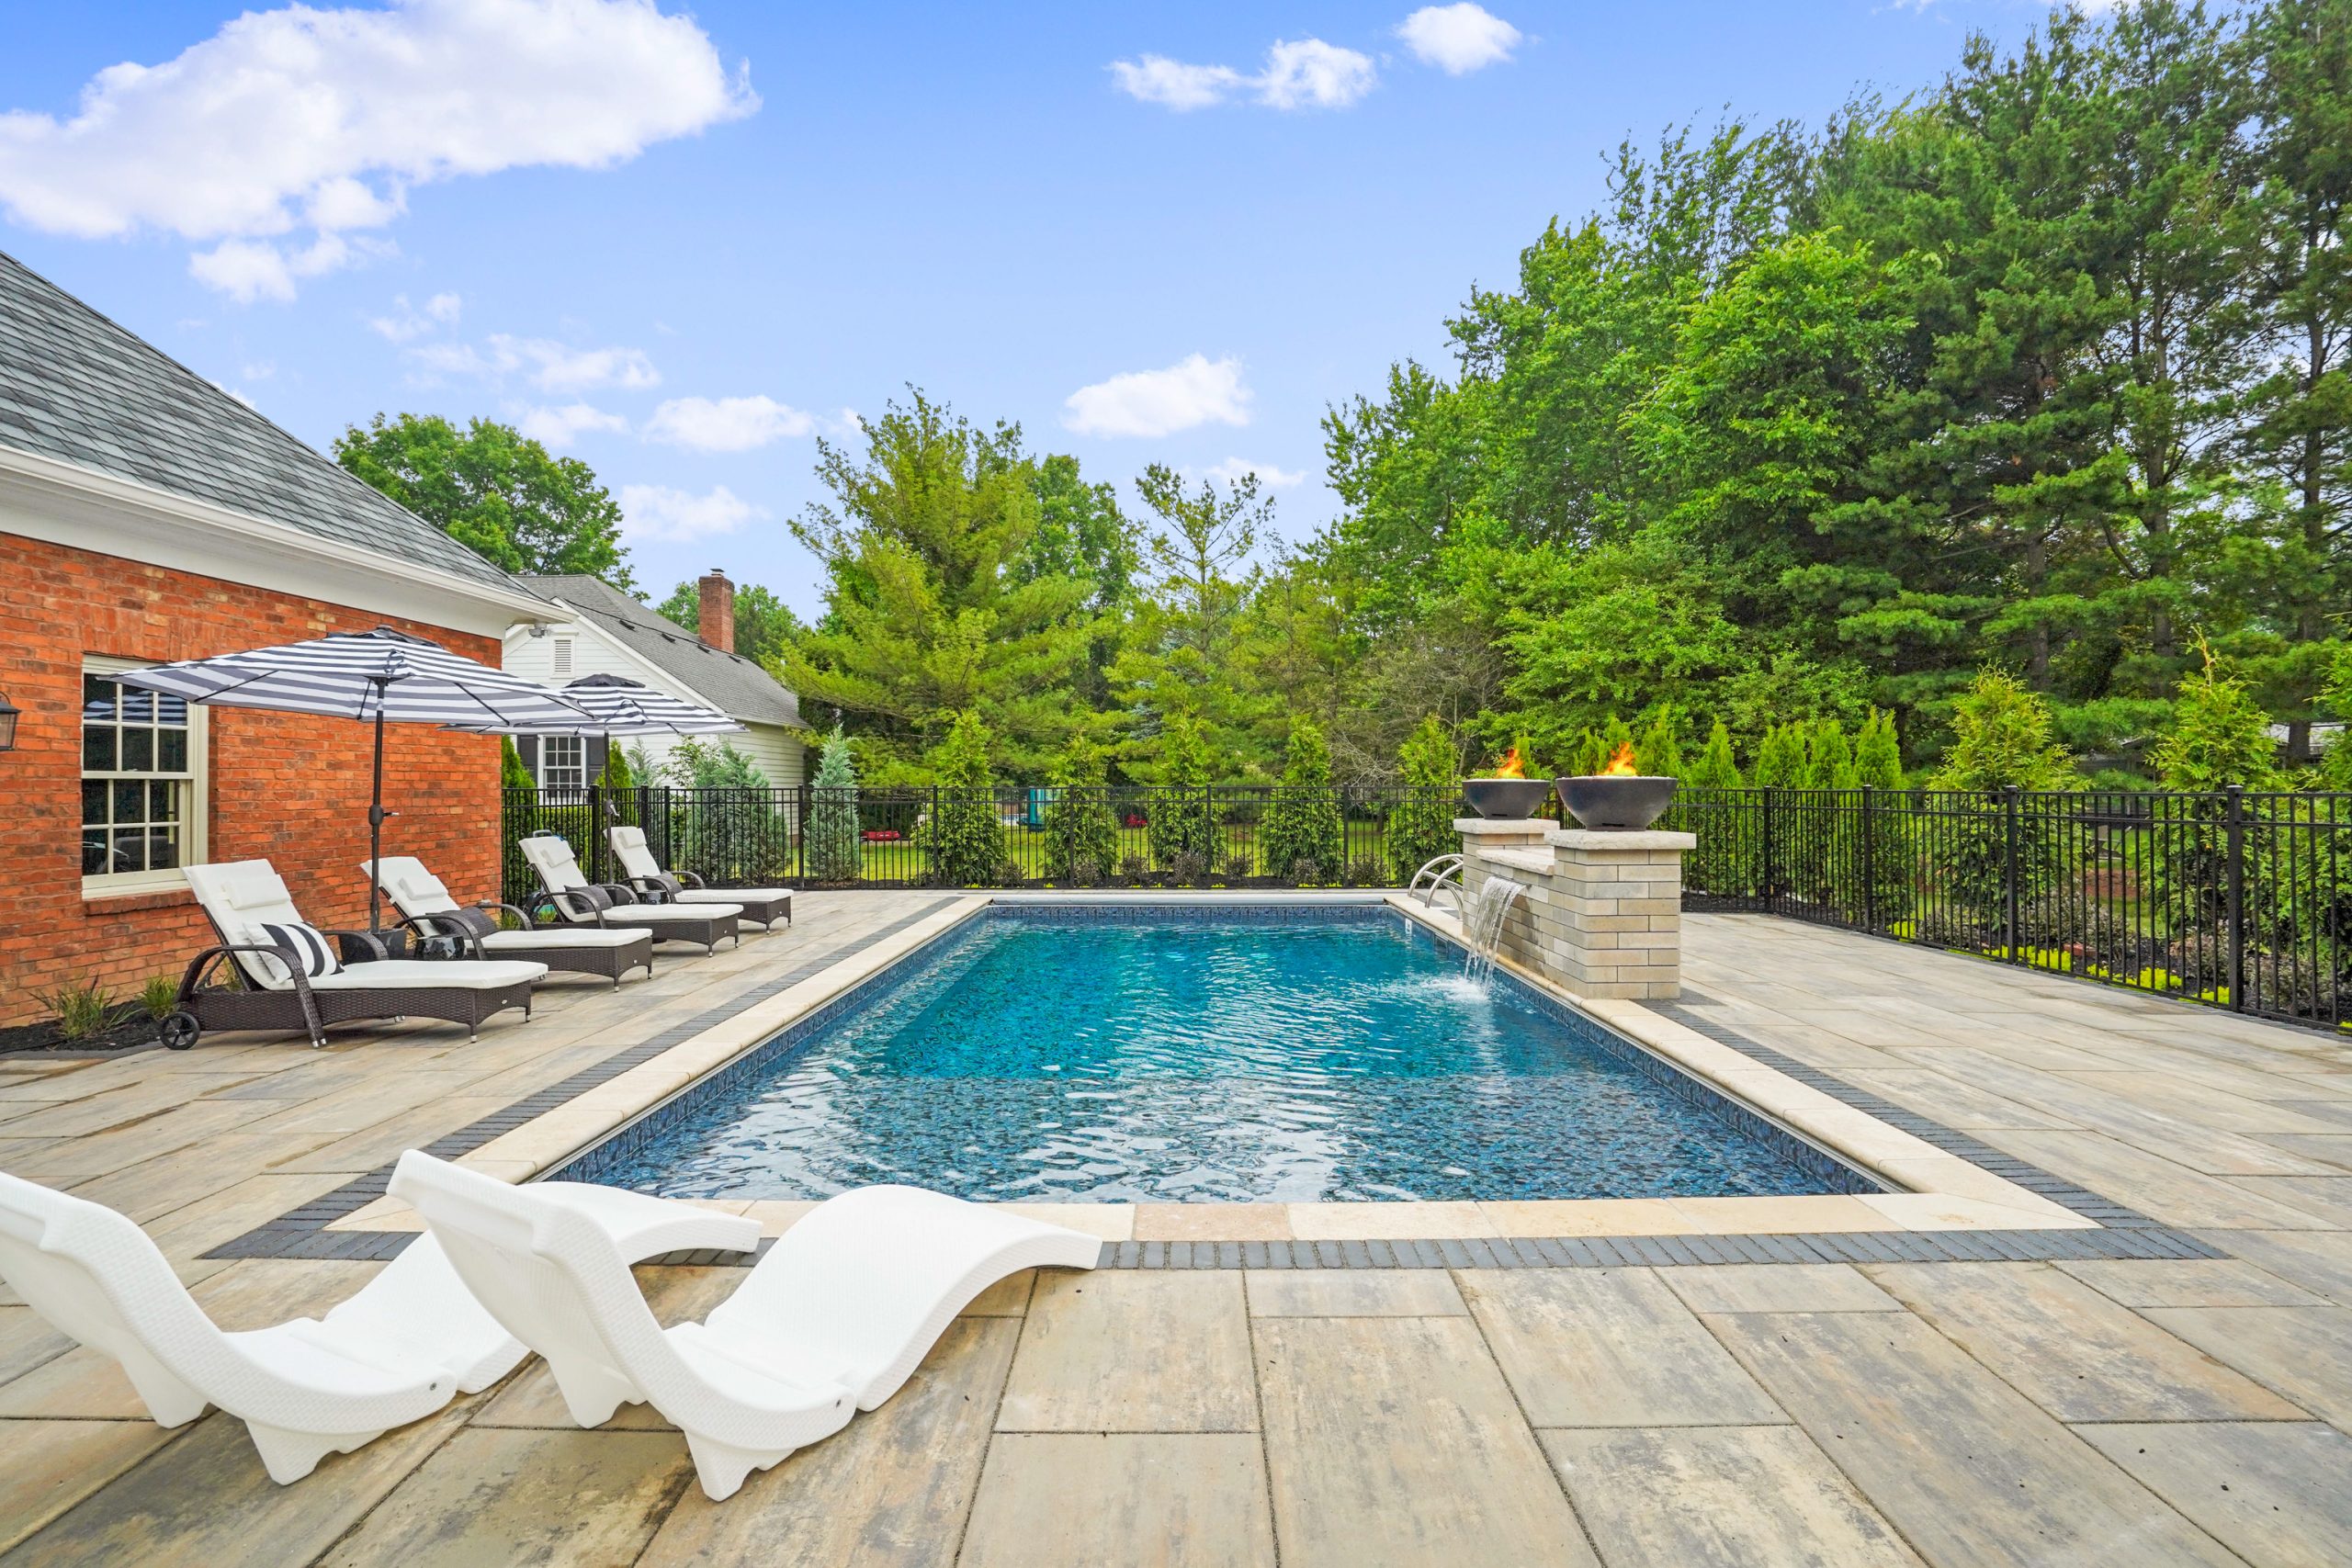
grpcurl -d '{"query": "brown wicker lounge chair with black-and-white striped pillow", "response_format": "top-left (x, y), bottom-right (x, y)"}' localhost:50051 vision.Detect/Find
top-left (163, 861), bottom-right (548, 1051)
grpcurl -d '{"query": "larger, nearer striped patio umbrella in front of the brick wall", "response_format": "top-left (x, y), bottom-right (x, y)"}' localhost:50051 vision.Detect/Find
top-left (113, 626), bottom-right (581, 931)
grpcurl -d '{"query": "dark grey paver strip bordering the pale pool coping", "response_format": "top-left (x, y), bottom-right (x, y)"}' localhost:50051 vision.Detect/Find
top-left (205, 896), bottom-right (2227, 1269)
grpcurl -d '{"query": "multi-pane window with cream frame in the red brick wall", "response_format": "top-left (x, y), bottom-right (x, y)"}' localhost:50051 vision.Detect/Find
top-left (83, 659), bottom-right (205, 894)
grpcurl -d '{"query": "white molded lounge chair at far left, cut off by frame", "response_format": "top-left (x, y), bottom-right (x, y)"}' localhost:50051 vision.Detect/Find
top-left (0, 1176), bottom-right (760, 1483)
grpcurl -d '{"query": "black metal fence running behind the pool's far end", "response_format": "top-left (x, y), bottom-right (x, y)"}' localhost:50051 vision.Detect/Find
top-left (503, 785), bottom-right (1461, 903)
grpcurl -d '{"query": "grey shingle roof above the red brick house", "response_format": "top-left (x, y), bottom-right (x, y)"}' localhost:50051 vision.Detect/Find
top-left (0, 252), bottom-right (515, 588)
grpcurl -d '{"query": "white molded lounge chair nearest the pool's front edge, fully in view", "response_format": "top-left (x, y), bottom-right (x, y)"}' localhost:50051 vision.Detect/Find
top-left (390, 1152), bottom-right (1103, 1500)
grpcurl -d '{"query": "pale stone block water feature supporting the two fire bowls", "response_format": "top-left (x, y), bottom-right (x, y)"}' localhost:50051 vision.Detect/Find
top-left (1453, 818), bottom-right (1698, 1001)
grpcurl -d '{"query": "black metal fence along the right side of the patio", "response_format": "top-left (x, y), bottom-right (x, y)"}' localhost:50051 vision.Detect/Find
top-left (1665, 790), bottom-right (2352, 1025)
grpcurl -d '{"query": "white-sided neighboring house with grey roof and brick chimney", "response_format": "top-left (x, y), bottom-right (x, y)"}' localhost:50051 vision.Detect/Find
top-left (505, 573), bottom-right (807, 790)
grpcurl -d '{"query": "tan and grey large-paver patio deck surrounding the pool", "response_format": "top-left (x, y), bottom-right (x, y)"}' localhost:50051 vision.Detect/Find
top-left (0, 894), bottom-right (2352, 1568)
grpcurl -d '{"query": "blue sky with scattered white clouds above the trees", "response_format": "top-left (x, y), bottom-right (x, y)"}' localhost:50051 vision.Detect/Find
top-left (0, 0), bottom-right (2041, 611)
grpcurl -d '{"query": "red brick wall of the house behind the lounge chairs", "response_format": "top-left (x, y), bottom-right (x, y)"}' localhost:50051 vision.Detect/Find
top-left (0, 534), bottom-right (499, 1025)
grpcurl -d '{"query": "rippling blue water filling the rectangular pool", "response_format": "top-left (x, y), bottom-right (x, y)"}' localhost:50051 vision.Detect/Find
top-left (567, 908), bottom-right (1868, 1201)
